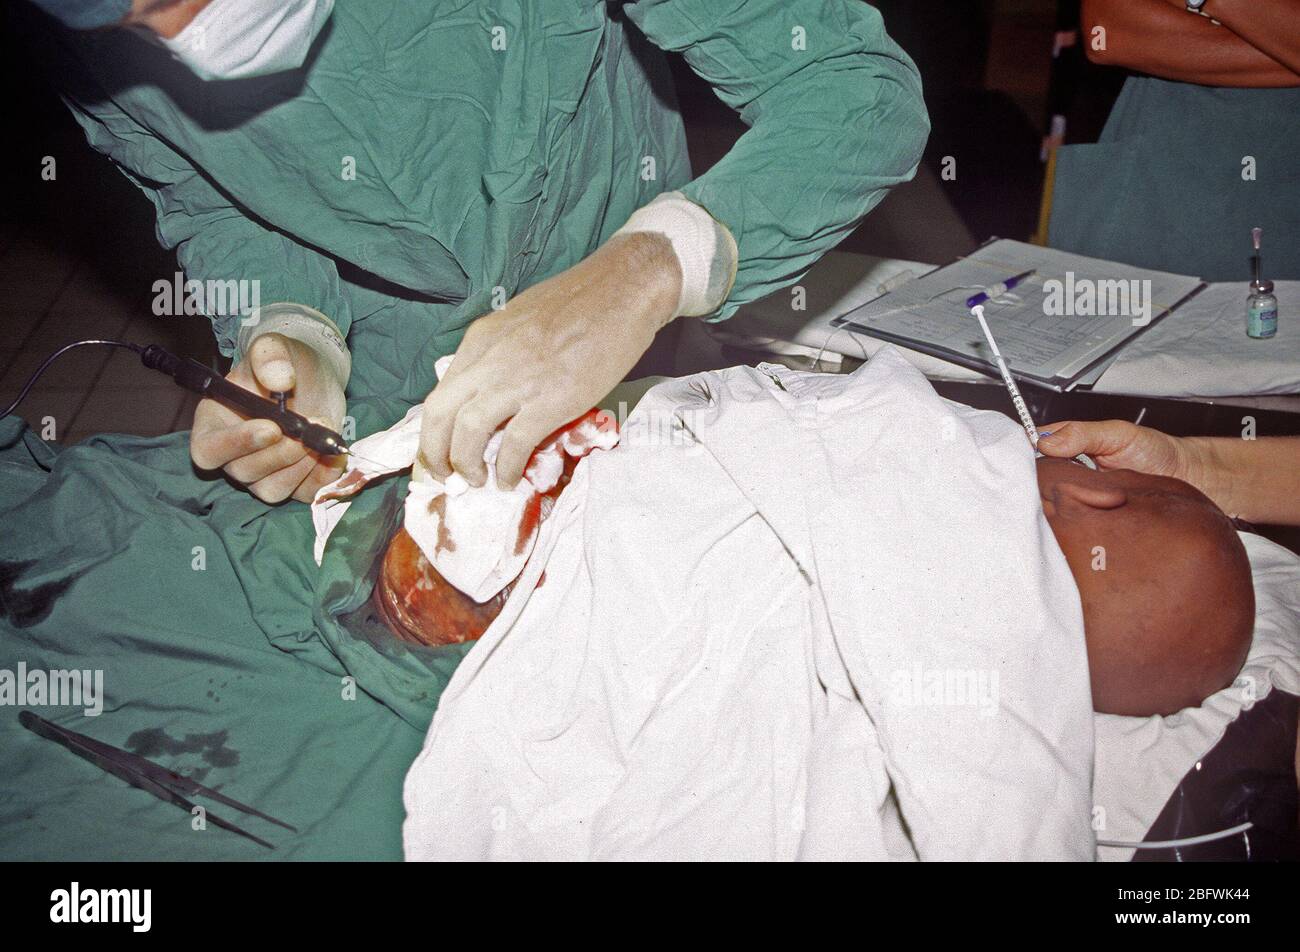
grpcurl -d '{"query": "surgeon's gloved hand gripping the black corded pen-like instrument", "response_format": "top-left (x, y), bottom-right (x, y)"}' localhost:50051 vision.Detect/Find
top-left (190, 333), bottom-right (347, 503)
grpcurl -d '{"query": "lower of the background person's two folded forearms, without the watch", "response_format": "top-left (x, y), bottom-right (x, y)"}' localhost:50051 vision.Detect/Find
top-left (1080, 0), bottom-right (1300, 87)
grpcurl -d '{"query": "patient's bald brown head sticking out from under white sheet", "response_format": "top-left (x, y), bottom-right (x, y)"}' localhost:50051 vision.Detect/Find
top-left (1037, 459), bottom-right (1255, 715)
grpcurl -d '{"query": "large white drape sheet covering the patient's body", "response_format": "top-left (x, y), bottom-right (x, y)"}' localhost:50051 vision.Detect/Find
top-left (404, 349), bottom-right (1095, 860)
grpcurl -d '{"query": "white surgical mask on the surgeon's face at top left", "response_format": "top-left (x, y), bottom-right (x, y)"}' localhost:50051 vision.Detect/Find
top-left (163, 0), bottom-right (334, 79)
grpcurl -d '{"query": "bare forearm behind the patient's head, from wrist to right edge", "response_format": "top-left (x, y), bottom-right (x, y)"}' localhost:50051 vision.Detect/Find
top-left (1180, 437), bottom-right (1300, 525)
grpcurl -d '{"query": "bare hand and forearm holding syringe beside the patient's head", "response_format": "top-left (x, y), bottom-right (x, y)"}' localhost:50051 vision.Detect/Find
top-left (1039, 420), bottom-right (1300, 525)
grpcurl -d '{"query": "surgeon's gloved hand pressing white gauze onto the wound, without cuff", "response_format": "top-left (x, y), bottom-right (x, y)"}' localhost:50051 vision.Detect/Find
top-left (420, 231), bottom-right (683, 489)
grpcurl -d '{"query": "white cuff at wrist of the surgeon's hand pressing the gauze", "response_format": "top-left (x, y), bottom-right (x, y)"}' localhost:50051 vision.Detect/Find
top-left (615, 191), bottom-right (740, 317)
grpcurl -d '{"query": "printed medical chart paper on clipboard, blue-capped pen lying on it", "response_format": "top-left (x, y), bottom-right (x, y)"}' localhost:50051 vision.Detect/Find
top-left (832, 238), bottom-right (1205, 390)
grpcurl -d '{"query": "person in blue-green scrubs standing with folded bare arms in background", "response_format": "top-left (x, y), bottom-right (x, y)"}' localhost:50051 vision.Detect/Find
top-left (1049, 0), bottom-right (1300, 280)
